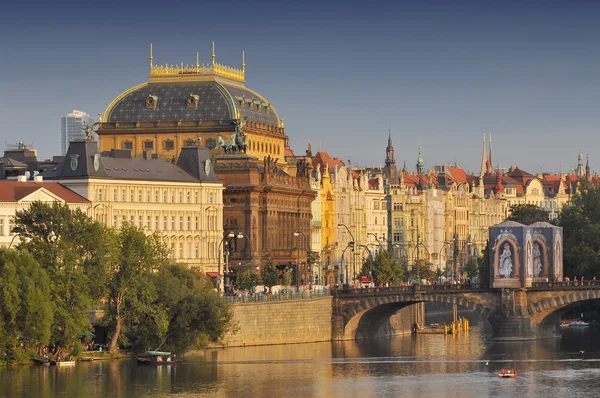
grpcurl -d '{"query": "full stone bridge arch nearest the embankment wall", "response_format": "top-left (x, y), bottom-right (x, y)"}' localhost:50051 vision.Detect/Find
top-left (339, 294), bottom-right (494, 340)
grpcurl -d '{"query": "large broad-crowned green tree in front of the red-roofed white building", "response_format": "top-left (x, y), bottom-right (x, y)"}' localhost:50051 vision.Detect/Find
top-left (13, 202), bottom-right (114, 357)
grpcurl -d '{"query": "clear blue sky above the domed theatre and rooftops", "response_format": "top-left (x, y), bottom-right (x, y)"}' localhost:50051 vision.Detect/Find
top-left (0, 0), bottom-right (600, 173)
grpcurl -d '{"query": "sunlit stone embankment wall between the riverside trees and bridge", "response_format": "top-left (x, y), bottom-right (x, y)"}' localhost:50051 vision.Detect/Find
top-left (216, 297), bottom-right (332, 347)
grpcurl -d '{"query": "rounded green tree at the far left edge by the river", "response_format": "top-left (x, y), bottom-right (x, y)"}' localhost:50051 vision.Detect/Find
top-left (0, 249), bottom-right (53, 357)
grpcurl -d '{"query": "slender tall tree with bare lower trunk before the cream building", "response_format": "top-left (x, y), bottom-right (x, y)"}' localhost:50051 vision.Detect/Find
top-left (106, 223), bottom-right (169, 351)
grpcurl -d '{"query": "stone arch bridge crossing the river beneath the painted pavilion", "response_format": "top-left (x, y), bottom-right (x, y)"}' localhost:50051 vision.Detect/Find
top-left (332, 281), bottom-right (600, 340)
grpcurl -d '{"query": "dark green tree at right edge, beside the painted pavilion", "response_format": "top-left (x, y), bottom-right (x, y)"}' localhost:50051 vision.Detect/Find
top-left (558, 180), bottom-right (600, 279)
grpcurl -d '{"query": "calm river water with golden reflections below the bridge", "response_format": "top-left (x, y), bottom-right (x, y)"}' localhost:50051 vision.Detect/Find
top-left (0, 317), bottom-right (600, 398)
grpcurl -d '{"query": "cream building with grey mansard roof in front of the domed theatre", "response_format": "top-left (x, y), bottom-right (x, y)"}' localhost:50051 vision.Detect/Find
top-left (42, 140), bottom-right (223, 276)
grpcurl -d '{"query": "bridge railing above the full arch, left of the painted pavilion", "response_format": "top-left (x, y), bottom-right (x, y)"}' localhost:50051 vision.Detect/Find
top-left (331, 283), bottom-right (489, 297)
